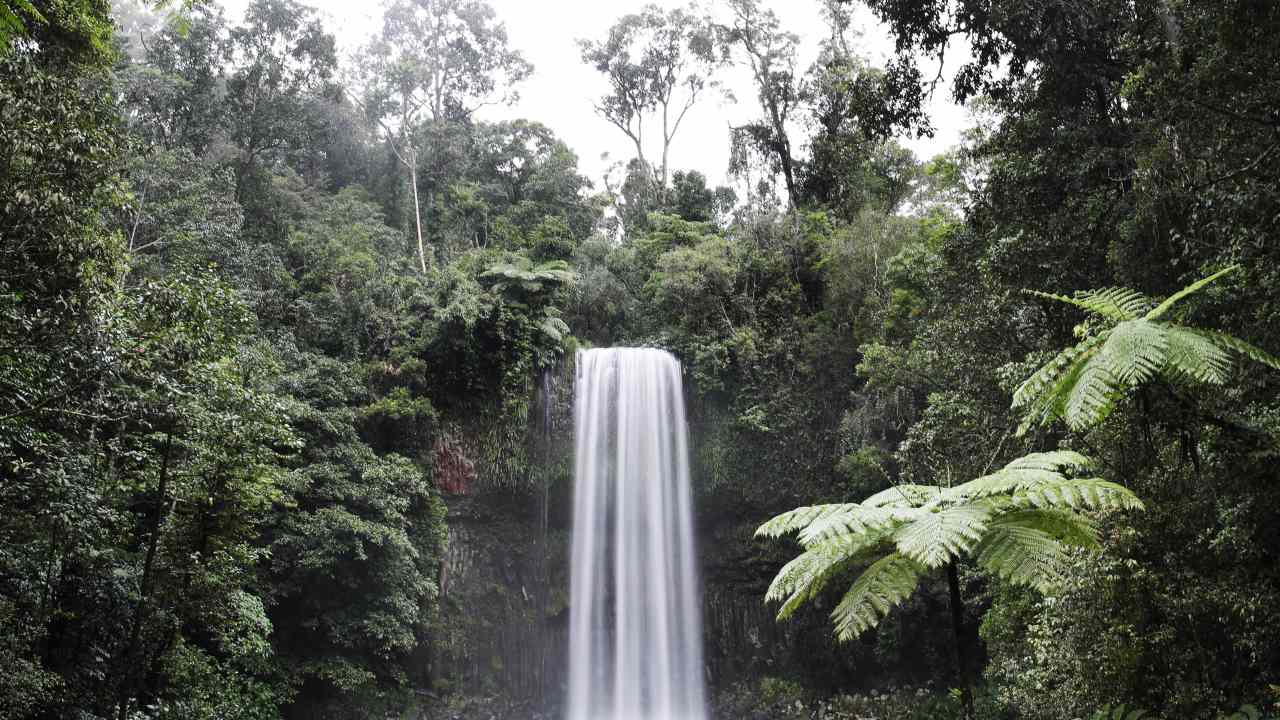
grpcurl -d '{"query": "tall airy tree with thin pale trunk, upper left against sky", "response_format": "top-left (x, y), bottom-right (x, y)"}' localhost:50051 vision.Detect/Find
top-left (353, 0), bottom-right (532, 273)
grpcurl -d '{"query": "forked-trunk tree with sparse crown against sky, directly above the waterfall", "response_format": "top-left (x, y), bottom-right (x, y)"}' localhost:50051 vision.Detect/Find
top-left (579, 5), bottom-right (719, 193)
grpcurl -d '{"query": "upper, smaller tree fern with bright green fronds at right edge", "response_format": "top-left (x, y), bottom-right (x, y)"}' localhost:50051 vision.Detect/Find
top-left (1012, 265), bottom-right (1280, 433)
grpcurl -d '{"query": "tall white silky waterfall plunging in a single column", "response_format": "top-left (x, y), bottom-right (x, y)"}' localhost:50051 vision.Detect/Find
top-left (568, 348), bottom-right (705, 720)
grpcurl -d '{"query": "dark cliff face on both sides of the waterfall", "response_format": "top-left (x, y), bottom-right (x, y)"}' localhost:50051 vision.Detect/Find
top-left (422, 370), bottom-right (948, 720)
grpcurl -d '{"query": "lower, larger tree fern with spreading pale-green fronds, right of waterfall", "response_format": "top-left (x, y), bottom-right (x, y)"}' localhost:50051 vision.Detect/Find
top-left (756, 450), bottom-right (1142, 639)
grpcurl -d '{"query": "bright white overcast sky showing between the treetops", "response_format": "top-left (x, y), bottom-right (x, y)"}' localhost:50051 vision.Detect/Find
top-left (220, 0), bottom-right (969, 188)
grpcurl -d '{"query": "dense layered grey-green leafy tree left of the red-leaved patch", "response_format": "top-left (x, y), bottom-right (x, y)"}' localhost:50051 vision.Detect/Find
top-left (262, 355), bottom-right (444, 716)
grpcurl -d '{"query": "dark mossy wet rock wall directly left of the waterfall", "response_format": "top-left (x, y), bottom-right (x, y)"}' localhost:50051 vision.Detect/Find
top-left (420, 363), bottom-right (572, 720)
